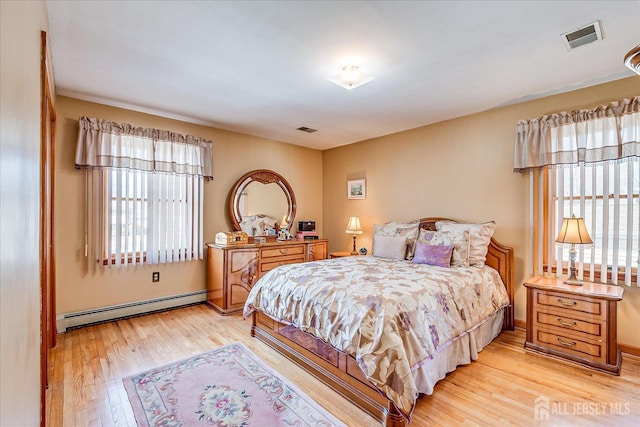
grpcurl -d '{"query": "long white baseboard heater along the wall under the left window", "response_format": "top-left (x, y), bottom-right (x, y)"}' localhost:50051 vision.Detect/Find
top-left (56, 290), bottom-right (207, 333)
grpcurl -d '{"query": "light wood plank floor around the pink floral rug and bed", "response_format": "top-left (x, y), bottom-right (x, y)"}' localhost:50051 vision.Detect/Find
top-left (46, 305), bottom-right (640, 427)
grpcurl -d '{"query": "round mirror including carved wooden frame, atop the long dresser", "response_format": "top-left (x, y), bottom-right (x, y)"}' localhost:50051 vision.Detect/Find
top-left (229, 169), bottom-right (296, 236)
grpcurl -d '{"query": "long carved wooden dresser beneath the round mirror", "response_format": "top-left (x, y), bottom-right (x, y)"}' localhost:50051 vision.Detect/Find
top-left (207, 239), bottom-right (328, 314)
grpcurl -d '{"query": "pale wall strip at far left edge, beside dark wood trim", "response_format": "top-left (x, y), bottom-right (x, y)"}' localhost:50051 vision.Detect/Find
top-left (0, 1), bottom-right (47, 426)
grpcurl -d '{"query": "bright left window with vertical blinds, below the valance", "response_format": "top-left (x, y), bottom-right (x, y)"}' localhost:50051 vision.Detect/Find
top-left (103, 168), bottom-right (203, 265)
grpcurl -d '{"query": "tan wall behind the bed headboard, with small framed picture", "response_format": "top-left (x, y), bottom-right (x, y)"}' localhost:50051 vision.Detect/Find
top-left (323, 77), bottom-right (640, 347)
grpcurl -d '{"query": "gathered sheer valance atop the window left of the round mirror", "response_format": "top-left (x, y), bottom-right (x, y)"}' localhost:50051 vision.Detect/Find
top-left (76, 116), bottom-right (213, 178)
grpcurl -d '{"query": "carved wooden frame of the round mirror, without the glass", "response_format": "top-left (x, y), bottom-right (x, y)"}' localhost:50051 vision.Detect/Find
top-left (229, 169), bottom-right (297, 234)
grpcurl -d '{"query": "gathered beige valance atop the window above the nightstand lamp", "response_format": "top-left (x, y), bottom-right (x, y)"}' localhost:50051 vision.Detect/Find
top-left (513, 96), bottom-right (640, 172)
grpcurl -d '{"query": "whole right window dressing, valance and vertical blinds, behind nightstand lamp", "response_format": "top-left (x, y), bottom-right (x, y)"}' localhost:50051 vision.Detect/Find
top-left (514, 96), bottom-right (640, 285)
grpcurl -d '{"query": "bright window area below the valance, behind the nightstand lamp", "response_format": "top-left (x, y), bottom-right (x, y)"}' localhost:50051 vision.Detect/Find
top-left (545, 159), bottom-right (640, 283)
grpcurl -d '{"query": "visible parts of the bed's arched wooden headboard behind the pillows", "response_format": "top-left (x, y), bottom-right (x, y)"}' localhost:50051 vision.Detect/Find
top-left (420, 217), bottom-right (515, 331)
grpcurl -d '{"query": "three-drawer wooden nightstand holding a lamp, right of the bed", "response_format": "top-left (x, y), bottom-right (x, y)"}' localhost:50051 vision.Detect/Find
top-left (524, 276), bottom-right (624, 375)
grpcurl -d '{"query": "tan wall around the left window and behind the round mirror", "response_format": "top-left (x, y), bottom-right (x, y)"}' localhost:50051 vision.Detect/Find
top-left (55, 96), bottom-right (322, 315)
